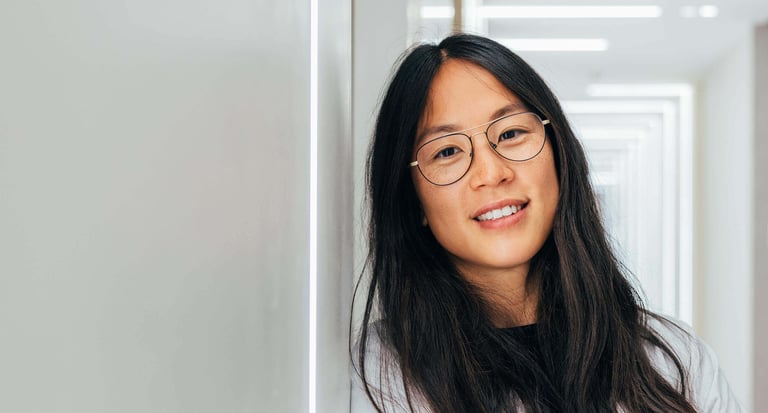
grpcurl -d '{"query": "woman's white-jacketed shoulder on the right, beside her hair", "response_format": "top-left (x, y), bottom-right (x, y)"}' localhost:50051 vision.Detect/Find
top-left (647, 314), bottom-right (741, 413)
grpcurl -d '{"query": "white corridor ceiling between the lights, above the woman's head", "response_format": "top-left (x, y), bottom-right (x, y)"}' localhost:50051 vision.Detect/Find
top-left (417, 0), bottom-right (768, 99)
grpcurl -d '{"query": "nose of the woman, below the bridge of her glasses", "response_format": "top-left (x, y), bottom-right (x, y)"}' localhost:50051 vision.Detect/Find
top-left (469, 132), bottom-right (514, 188)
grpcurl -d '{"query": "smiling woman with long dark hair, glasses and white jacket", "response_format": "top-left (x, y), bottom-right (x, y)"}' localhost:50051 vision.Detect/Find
top-left (353, 34), bottom-right (740, 413)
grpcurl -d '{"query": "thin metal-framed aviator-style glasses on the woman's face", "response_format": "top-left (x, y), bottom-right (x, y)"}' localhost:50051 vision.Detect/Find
top-left (409, 112), bottom-right (549, 186)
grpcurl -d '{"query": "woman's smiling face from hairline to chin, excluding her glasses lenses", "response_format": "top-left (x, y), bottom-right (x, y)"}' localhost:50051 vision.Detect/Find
top-left (412, 59), bottom-right (558, 281)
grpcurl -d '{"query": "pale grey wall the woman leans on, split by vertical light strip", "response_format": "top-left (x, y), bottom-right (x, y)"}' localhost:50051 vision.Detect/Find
top-left (0, 0), bottom-right (351, 413)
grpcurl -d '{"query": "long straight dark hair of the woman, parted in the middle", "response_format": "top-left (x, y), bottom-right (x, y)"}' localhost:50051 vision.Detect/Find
top-left (353, 34), bottom-right (694, 413)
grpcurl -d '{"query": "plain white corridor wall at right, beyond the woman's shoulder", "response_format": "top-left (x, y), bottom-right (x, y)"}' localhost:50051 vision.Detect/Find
top-left (694, 27), bottom-right (754, 412)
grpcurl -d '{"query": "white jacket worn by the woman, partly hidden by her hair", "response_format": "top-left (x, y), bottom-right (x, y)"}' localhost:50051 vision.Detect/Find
top-left (352, 318), bottom-right (742, 413)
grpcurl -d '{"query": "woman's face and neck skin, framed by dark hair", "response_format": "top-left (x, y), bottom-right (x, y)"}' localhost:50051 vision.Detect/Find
top-left (412, 59), bottom-right (558, 323)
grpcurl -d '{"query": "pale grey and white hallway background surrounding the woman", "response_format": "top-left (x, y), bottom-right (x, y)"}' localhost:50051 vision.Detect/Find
top-left (0, 0), bottom-right (768, 412)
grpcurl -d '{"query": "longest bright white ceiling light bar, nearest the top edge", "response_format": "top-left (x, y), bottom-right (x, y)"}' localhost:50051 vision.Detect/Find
top-left (479, 6), bottom-right (661, 19)
